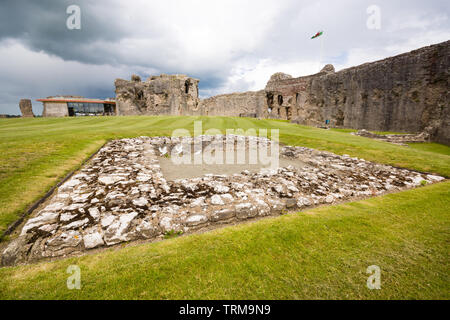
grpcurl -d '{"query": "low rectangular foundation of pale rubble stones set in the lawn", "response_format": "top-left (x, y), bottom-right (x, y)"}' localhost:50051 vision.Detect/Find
top-left (2, 136), bottom-right (444, 265)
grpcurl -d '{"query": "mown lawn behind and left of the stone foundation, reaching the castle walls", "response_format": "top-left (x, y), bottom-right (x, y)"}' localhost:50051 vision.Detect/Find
top-left (0, 117), bottom-right (450, 234)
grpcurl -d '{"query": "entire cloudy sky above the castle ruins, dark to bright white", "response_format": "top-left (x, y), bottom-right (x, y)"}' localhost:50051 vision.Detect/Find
top-left (0, 0), bottom-right (450, 114)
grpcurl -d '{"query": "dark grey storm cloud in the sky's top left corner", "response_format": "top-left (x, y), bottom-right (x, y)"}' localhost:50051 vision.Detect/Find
top-left (0, 0), bottom-right (125, 63)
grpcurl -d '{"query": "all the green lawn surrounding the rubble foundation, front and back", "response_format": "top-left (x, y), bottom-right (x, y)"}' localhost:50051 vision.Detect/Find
top-left (0, 117), bottom-right (450, 299)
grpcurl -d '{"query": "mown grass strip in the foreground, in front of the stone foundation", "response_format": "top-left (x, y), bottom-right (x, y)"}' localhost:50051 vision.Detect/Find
top-left (0, 182), bottom-right (450, 299)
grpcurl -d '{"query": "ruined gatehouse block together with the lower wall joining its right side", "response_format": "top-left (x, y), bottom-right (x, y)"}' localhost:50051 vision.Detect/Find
top-left (115, 74), bottom-right (267, 117)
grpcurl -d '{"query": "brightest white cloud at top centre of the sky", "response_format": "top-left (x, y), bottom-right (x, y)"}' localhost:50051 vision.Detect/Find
top-left (104, 0), bottom-right (292, 73)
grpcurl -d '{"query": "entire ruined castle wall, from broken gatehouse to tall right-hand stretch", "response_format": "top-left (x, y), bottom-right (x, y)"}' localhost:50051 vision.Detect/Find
top-left (115, 41), bottom-right (450, 144)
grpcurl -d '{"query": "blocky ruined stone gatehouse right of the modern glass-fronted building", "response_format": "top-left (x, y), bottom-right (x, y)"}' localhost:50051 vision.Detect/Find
top-left (115, 74), bottom-right (200, 115)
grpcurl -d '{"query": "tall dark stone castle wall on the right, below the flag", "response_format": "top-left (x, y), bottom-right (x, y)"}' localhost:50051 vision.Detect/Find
top-left (266, 41), bottom-right (450, 144)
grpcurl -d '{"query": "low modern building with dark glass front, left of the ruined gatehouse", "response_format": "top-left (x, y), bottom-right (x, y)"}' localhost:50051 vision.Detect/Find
top-left (37, 96), bottom-right (116, 117)
